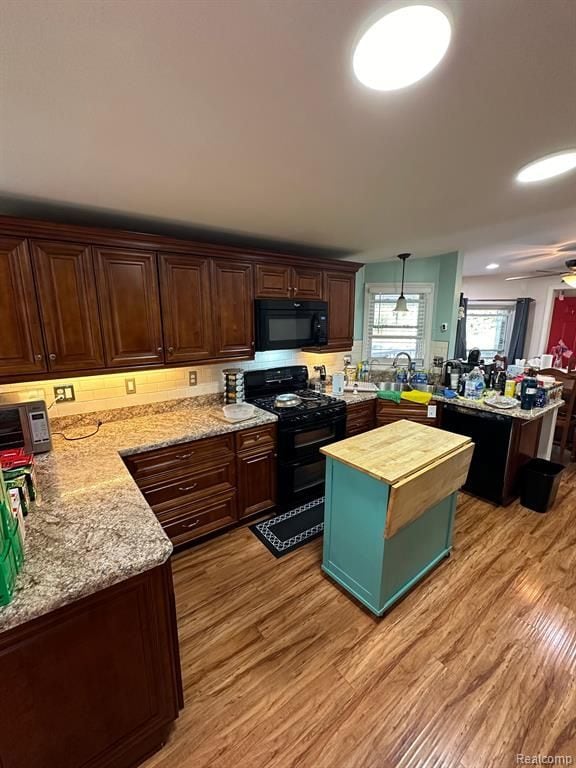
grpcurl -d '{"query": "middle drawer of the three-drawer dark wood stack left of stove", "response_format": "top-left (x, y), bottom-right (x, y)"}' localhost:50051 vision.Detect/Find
top-left (142, 458), bottom-right (236, 512)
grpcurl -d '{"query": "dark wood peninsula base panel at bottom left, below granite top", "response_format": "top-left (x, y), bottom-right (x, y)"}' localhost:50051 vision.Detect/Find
top-left (0, 563), bottom-right (183, 768)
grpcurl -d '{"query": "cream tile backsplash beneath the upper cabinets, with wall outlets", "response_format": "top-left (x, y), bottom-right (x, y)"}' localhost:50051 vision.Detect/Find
top-left (0, 350), bottom-right (344, 417)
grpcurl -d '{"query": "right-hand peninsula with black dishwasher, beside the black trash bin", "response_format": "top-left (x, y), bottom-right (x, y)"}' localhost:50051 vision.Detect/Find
top-left (434, 396), bottom-right (563, 506)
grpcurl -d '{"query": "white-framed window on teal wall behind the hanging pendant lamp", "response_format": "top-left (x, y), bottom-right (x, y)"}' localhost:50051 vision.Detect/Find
top-left (363, 283), bottom-right (433, 366)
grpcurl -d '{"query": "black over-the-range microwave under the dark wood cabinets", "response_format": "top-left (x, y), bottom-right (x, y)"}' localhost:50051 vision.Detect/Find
top-left (255, 299), bottom-right (328, 352)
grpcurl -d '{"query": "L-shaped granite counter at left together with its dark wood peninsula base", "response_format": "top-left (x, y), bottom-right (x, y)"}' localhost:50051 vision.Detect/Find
top-left (0, 398), bottom-right (276, 768)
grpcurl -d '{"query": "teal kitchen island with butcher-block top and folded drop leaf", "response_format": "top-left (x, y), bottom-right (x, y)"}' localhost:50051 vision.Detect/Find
top-left (322, 420), bottom-right (473, 616)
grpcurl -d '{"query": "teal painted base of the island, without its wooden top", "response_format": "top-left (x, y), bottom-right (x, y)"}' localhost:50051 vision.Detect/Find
top-left (322, 457), bottom-right (457, 616)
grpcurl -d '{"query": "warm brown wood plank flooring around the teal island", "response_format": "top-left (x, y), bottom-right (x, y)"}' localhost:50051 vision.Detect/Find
top-left (145, 465), bottom-right (576, 768)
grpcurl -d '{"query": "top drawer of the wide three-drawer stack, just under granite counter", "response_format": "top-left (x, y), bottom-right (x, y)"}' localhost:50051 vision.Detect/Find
top-left (124, 434), bottom-right (234, 480)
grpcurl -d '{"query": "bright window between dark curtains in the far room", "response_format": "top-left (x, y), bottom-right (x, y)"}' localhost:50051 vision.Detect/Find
top-left (466, 301), bottom-right (514, 361)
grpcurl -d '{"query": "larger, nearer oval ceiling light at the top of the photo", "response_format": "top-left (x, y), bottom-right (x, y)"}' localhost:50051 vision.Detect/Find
top-left (352, 5), bottom-right (452, 91)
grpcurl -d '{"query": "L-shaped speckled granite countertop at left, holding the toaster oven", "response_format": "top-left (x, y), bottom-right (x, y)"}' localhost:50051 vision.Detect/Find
top-left (0, 398), bottom-right (276, 632)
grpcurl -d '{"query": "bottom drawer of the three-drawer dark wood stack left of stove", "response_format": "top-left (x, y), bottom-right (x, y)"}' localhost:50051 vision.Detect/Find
top-left (158, 492), bottom-right (237, 544)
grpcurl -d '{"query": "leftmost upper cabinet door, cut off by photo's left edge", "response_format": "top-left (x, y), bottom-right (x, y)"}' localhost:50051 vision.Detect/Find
top-left (0, 237), bottom-right (47, 376)
